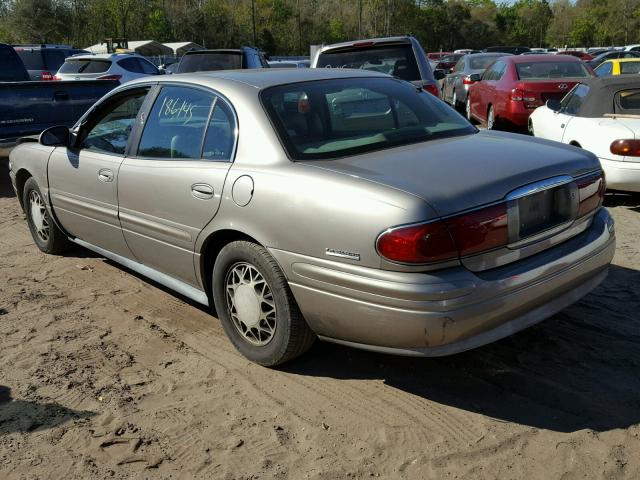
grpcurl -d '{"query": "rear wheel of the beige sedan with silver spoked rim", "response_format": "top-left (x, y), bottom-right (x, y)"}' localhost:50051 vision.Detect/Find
top-left (212, 241), bottom-right (315, 367)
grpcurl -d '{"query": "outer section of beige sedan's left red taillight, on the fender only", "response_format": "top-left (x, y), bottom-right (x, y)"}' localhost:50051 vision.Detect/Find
top-left (377, 221), bottom-right (458, 263)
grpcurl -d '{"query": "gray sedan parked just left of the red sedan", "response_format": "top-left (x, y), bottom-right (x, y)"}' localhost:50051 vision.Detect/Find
top-left (442, 52), bottom-right (511, 108)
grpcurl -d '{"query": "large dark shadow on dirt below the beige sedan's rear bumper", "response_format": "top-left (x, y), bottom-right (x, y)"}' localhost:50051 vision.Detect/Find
top-left (282, 266), bottom-right (640, 432)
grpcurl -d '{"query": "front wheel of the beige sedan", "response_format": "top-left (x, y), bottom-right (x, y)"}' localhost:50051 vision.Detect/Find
top-left (22, 177), bottom-right (71, 255)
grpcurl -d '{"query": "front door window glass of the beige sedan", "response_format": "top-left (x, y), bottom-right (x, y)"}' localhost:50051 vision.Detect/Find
top-left (82, 88), bottom-right (148, 155)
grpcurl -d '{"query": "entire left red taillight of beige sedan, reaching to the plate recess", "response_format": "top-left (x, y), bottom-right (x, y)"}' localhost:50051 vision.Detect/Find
top-left (377, 203), bottom-right (509, 263)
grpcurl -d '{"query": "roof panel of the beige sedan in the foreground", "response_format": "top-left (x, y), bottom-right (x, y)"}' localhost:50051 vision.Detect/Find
top-left (127, 68), bottom-right (393, 89)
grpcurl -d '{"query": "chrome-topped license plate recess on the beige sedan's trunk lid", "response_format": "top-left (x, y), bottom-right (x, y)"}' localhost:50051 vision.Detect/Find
top-left (507, 177), bottom-right (580, 244)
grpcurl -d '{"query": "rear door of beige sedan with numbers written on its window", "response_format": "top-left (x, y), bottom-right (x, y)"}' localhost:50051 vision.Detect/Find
top-left (118, 84), bottom-right (237, 286)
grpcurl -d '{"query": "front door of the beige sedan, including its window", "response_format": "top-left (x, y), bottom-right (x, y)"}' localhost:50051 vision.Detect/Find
top-left (48, 87), bottom-right (149, 258)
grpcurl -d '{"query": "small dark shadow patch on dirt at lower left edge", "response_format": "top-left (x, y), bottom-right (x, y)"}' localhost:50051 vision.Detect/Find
top-left (0, 385), bottom-right (96, 435)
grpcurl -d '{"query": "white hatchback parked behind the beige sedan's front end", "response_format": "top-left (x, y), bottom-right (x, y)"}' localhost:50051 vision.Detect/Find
top-left (54, 53), bottom-right (161, 83)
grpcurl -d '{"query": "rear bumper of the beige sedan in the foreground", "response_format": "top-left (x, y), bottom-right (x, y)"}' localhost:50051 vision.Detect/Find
top-left (272, 209), bottom-right (615, 356)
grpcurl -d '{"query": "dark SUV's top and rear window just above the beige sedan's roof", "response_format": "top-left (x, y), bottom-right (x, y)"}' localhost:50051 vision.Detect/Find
top-left (176, 47), bottom-right (269, 73)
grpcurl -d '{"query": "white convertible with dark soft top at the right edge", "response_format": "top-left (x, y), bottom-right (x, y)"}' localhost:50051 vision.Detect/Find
top-left (529, 75), bottom-right (640, 192)
